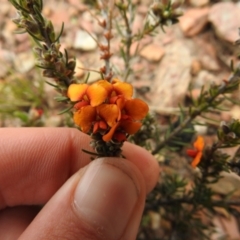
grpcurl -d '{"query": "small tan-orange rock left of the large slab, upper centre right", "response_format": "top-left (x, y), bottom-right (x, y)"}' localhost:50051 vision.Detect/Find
top-left (140, 44), bottom-right (165, 62)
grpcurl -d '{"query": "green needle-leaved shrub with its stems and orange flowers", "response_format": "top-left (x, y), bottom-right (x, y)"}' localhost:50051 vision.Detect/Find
top-left (5, 0), bottom-right (240, 239)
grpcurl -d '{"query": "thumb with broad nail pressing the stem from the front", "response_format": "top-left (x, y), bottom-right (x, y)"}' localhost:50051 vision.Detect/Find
top-left (19, 158), bottom-right (146, 240)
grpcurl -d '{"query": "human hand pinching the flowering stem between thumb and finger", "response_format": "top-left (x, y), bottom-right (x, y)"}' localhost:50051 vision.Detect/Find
top-left (0, 128), bottom-right (159, 240)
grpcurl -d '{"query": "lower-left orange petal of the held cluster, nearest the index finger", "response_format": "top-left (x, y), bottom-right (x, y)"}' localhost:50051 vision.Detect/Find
top-left (73, 105), bottom-right (96, 133)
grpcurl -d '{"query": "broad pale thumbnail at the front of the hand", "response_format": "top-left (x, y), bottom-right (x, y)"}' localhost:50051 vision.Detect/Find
top-left (74, 158), bottom-right (139, 240)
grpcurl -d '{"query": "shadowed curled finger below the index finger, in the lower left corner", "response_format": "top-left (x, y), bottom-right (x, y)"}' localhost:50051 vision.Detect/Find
top-left (0, 206), bottom-right (40, 240)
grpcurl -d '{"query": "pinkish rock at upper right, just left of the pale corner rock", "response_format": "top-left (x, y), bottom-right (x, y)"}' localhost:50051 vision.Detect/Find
top-left (179, 7), bottom-right (209, 37)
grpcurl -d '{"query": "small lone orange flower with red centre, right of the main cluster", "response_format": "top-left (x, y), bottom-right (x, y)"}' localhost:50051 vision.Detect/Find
top-left (187, 136), bottom-right (204, 168)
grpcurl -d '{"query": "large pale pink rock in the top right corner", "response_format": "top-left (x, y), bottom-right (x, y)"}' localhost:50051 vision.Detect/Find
top-left (209, 2), bottom-right (240, 43)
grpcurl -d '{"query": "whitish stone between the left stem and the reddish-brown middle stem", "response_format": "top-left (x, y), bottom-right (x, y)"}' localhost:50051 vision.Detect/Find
top-left (73, 30), bottom-right (97, 51)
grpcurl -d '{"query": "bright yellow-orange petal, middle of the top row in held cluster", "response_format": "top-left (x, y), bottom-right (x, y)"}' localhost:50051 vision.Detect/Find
top-left (87, 80), bottom-right (112, 107)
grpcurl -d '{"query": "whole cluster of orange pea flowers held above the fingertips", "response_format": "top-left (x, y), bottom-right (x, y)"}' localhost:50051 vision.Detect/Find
top-left (68, 79), bottom-right (148, 142)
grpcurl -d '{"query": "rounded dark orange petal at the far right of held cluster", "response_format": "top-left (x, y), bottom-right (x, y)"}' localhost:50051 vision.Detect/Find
top-left (124, 98), bottom-right (148, 120)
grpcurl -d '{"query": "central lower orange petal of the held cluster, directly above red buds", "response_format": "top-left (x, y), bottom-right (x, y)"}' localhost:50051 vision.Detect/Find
top-left (97, 104), bottom-right (120, 127)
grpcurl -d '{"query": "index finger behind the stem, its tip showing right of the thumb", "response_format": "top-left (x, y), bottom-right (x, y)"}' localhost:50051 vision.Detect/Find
top-left (0, 128), bottom-right (159, 209)
